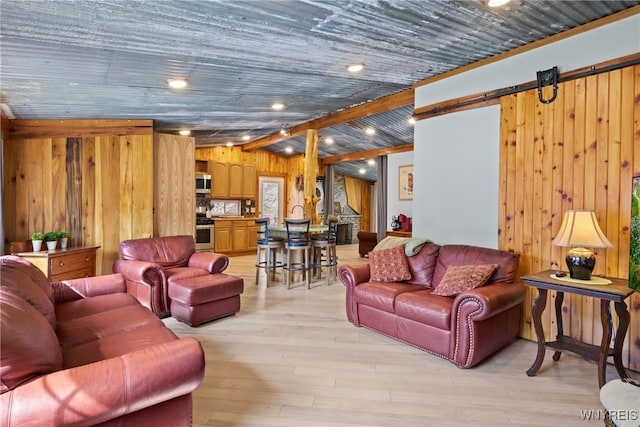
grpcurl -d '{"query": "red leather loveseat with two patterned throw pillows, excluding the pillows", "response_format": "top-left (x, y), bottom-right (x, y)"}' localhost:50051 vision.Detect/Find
top-left (338, 243), bottom-right (525, 368)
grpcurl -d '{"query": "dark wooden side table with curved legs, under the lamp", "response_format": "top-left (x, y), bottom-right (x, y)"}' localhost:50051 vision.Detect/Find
top-left (522, 270), bottom-right (634, 387)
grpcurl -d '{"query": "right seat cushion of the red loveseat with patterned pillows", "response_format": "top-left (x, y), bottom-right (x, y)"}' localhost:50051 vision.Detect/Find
top-left (395, 289), bottom-right (453, 331)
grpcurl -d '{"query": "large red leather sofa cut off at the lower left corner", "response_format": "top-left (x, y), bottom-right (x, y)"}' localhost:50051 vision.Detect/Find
top-left (0, 255), bottom-right (204, 427)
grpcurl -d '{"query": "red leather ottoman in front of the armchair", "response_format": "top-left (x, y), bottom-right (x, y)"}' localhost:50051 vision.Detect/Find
top-left (169, 273), bottom-right (244, 326)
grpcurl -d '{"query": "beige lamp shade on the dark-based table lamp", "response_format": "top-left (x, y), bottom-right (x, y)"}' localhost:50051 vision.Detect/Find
top-left (551, 210), bottom-right (613, 248)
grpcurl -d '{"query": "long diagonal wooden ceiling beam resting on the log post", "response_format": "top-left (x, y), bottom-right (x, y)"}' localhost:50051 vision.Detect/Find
top-left (242, 88), bottom-right (413, 151)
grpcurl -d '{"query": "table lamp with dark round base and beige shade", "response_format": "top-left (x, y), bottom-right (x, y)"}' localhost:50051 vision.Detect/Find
top-left (551, 210), bottom-right (613, 280)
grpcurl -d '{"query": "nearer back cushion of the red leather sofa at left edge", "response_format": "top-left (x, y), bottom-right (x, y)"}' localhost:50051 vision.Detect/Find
top-left (0, 286), bottom-right (62, 393)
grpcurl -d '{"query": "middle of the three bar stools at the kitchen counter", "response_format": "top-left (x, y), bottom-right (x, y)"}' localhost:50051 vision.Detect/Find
top-left (284, 218), bottom-right (311, 289)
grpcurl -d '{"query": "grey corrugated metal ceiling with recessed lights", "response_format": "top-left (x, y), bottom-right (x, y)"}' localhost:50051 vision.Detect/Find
top-left (0, 0), bottom-right (640, 179)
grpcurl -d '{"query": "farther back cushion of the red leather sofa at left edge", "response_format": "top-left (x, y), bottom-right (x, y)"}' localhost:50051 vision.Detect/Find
top-left (0, 256), bottom-right (56, 328)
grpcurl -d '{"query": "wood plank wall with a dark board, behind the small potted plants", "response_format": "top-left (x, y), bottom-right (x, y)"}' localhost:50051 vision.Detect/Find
top-left (2, 120), bottom-right (153, 274)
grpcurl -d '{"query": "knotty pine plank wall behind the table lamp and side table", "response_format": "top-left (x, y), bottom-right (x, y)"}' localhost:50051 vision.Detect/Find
top-left (499, 66), bottom-right (640, 371)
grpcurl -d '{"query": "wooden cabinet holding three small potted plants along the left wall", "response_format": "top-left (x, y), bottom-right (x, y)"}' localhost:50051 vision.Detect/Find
top-left (16, 246), bottom-right (100, 282)
